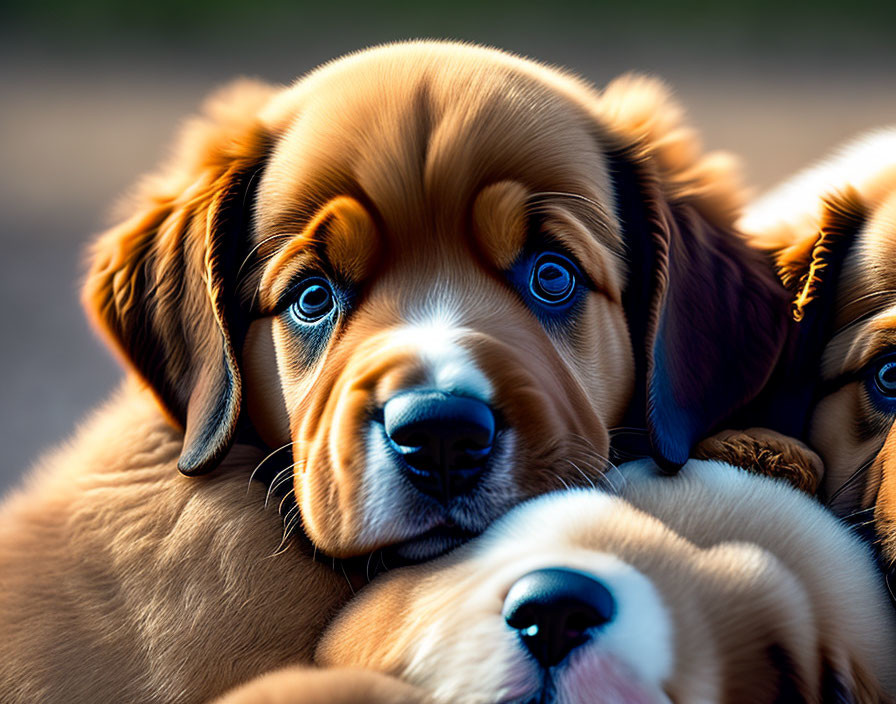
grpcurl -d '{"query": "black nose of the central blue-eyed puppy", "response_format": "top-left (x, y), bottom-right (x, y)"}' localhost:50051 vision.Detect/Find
top-left (383, 391), bottom-right (495, 500)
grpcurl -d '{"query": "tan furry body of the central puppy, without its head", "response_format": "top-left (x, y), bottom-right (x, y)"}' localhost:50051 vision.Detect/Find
top-left (0, 384), bottom-right (351, 704)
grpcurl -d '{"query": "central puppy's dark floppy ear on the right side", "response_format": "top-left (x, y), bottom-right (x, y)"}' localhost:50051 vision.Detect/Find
top-left (599, 77), bottom-right (787, 471)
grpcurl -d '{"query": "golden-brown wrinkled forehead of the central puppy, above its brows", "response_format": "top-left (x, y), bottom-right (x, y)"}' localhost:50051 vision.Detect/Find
top-left (248, 44), bottom-right (614, 253)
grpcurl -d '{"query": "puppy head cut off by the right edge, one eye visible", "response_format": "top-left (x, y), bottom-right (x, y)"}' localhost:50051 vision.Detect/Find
top-left (743, 130), bottom-right (896, 563)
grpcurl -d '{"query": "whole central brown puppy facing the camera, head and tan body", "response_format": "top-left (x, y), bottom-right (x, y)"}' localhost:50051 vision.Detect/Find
top-left (0, 43), bottom-right (787, 703)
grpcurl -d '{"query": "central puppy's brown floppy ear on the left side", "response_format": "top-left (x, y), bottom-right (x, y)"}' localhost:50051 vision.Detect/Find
top-left (83, 81), bottom-right (274, 475)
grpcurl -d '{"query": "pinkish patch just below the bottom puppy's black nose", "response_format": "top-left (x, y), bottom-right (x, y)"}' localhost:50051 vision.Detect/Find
top-left (557, 651), bottom-right (659, 704)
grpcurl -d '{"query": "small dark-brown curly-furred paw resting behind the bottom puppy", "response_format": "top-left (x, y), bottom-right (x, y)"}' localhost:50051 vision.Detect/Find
top-left (694, 428), bottom-right (824, 494)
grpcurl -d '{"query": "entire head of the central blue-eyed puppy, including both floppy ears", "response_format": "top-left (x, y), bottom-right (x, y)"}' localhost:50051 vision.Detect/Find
top-left (86, 43), bottom-right (783, 559)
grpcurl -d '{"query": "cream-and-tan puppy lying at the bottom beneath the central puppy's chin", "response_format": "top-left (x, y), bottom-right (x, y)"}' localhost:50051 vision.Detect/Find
top-left (318, 461), bottom-right (896, 702)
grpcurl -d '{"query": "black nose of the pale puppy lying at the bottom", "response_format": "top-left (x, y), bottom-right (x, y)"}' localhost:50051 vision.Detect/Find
top-left (503, 567), bottom-right (616, 669)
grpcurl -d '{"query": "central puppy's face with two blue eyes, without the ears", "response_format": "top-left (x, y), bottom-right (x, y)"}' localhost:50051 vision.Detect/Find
top-left (246, 63), bottom-right (634, 559)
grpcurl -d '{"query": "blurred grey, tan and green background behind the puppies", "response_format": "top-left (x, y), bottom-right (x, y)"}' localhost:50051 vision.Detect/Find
top-left (0, 0), bottom-right (896, 493)
